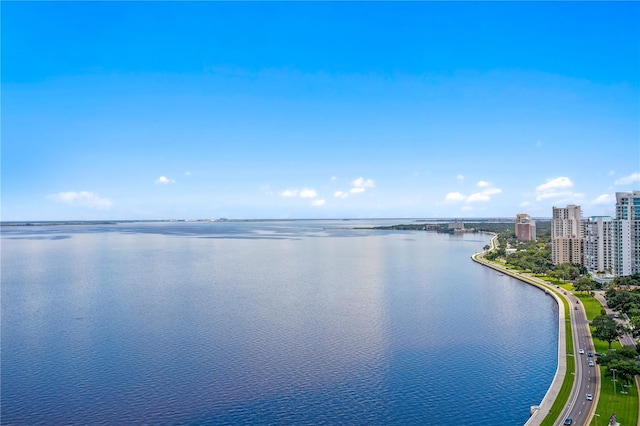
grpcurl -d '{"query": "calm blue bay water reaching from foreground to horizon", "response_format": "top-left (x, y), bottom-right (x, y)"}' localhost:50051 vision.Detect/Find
top-left (1, 220), bottom-right (557, 425)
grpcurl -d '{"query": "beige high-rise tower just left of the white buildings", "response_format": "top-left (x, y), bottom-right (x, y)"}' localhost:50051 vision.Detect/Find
top-left (551, 205), bottom-right (584, 265)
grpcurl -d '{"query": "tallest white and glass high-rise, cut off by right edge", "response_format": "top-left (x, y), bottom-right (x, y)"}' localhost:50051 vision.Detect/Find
top-left (612, 191), bottom-right (640, 276)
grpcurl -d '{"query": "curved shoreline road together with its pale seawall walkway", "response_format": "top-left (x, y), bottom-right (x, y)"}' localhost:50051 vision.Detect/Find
top-left (473, 238), bottom-right (600, 426)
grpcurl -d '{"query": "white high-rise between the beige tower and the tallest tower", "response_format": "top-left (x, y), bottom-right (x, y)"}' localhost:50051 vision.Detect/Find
top-left (584, 216), bottom-right (613, 274)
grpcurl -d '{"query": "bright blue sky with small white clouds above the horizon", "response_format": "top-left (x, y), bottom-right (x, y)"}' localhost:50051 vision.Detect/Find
top-left (1, 2), bottom-right (640, 220)
